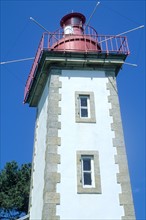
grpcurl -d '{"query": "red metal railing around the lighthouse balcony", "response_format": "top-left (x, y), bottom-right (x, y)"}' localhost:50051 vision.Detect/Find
top-left (24, 26), bottom-right (130, 103)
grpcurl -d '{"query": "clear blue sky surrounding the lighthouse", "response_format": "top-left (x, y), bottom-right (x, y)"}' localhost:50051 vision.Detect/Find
top-left (0, 0), bottom-right (146, 220)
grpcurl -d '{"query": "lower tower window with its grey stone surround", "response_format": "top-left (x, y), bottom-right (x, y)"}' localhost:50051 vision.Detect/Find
top-left (77, 151), bottom-right (101, 193)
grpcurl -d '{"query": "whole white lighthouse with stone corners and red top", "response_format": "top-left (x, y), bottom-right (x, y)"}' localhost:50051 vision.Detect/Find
top-left (24, 12), bottom-right (135, 220)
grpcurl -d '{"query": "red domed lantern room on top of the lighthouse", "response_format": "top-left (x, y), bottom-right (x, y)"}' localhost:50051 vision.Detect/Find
top-left (52, 12), bottom-right (101, 51)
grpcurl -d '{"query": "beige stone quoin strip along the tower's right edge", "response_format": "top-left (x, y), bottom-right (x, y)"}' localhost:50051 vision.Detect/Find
top-left (106, 71), bottom-right (135, 220)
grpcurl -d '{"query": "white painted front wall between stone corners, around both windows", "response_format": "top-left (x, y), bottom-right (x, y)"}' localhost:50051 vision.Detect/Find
top-left (57, 70), bottom-right (124, 220)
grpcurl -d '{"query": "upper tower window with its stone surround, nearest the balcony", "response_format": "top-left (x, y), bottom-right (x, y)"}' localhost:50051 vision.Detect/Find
top-left (75, 92), bottom-right (96, 123)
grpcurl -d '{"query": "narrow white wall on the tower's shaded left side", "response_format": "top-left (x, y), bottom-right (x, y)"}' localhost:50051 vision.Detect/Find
top-left (30, 78), bottom-right (48, 220)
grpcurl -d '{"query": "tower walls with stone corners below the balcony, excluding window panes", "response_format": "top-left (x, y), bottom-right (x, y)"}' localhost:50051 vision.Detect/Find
top-left (30, 68), bottom-right (135, 220)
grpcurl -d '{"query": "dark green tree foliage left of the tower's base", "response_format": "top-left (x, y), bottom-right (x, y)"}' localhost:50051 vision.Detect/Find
top-left (0, 161), bottom-right (31, 220)
